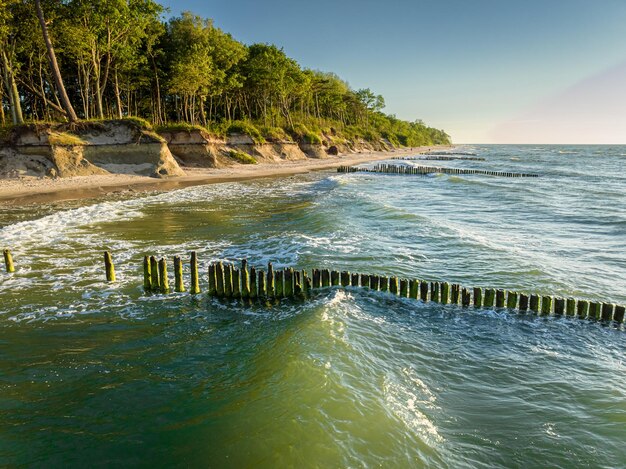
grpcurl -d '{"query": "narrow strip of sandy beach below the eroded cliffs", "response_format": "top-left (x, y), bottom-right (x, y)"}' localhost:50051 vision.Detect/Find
top-left (0, 145), bottom-right (444, 205)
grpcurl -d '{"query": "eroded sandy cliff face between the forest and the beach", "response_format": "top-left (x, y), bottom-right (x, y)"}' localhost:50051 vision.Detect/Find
top-left (0, 120), bottom-right (393, 178)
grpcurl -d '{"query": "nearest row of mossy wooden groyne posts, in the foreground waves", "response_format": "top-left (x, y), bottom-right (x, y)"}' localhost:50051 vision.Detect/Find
top-left (130, 253), bottom-right (625, 325)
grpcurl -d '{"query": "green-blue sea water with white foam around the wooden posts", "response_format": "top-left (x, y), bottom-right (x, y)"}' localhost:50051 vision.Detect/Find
top-left (0, 146), bottom-right (626, 467)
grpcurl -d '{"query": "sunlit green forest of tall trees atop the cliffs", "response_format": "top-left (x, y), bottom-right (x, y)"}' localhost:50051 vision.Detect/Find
top-left (0, 0), bottom-right (450, 146)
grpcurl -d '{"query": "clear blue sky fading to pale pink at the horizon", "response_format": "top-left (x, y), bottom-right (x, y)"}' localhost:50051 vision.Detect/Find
top-left (160, 0), bottom-right (626, 144)
